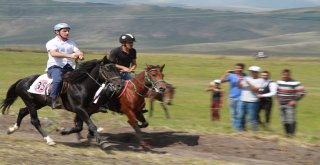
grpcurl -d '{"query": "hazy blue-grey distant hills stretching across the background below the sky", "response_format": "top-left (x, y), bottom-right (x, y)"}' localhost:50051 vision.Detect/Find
top-left (0, 0), bottom-right (320, 56)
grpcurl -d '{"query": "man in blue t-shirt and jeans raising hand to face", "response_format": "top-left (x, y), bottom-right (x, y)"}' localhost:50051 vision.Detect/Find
top-left (221, 63), bottom-right (246, 130)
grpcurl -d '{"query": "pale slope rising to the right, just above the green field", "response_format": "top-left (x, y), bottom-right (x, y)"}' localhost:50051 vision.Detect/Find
top-left (160, 31), bottom-right (320, 56)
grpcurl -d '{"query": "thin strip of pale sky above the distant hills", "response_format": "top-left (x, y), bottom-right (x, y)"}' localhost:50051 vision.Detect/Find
top-left (56, 0), bottom-right (320, 9)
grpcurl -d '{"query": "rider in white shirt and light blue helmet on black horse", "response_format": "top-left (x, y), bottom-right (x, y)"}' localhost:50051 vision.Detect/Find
top-left (46, 23), bottom-right (84, 109)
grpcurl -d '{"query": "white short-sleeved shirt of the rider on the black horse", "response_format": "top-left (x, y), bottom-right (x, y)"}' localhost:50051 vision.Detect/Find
top-left (46, 37), bottom-right (79, 70)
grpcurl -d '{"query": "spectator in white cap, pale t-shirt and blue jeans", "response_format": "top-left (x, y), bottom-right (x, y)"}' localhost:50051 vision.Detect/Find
top-left (238, 66), bottom-right (263, 131)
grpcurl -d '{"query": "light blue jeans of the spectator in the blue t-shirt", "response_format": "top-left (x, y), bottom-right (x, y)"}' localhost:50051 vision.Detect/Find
top-left (229, 97), bottom-right (240, 130)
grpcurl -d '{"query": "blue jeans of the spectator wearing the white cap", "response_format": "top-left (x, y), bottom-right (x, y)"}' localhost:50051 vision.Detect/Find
top-left (239, 101), bottom-right (259, 131)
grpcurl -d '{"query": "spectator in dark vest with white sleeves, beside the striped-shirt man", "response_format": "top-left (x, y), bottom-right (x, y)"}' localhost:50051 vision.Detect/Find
top-left (257, 71), bottom-right (277, 128)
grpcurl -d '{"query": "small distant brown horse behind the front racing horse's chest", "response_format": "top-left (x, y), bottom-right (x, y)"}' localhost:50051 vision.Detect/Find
top-left (148, 83), bottom-right (176, 119)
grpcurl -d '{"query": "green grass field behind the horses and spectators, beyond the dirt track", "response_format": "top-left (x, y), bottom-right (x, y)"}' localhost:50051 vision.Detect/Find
top-left (0, 51), bottom-right (320, 143)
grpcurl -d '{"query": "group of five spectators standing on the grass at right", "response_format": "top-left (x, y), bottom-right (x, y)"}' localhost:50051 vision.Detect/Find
top-left (206, 63), bottom-right (305, 137)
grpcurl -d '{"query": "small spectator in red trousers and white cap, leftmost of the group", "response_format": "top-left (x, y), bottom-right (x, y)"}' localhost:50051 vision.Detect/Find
top-left (206, 80), bottom-right (223, 121)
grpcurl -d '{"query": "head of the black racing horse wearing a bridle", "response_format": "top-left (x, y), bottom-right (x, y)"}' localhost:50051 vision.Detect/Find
top-left (99, 58), bottom-right (124, 92)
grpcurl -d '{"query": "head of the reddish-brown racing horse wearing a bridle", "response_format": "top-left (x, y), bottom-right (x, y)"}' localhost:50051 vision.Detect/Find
top-left (145, 64), bottom-right (166, 93)
